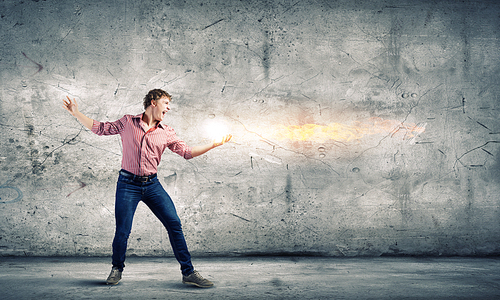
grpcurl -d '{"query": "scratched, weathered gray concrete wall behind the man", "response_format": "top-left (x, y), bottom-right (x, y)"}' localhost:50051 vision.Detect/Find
top-left (0, 0), bottom-right (500, 256)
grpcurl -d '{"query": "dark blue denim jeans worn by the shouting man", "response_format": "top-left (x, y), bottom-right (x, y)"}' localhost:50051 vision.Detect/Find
top-left (112, 170), bottom-right (194, 275)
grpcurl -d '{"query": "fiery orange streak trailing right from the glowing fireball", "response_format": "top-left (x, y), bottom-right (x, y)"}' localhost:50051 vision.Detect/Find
top-left (274, 118), bottom-right (425, 142)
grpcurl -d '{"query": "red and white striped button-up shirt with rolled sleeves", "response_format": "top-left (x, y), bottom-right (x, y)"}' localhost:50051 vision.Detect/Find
top-left (92, 114), bottom-right (193, 176)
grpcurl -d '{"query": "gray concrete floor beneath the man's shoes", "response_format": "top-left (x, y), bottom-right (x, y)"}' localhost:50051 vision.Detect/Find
top-left (0, 257), bottom-right (500, 299)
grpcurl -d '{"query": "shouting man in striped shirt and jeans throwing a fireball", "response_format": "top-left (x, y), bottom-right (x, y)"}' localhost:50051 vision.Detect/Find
top-left (63, 89), bottom-right (231, 287)
